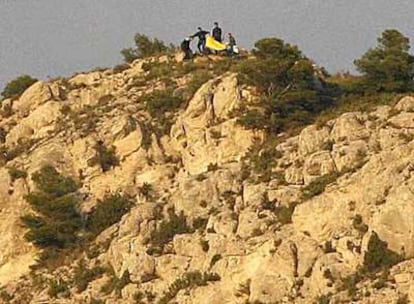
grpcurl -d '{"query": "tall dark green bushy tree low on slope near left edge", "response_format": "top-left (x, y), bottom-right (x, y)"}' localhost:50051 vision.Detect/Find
top-left (22, 166), bottom-right (83, 248)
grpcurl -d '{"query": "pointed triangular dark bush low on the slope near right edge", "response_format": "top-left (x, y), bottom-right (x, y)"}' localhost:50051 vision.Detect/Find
top-left (363, 232), bottom-right (403, 273)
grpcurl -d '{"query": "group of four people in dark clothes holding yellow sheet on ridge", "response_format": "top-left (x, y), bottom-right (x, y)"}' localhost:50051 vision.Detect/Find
top-left (181, 22), bottom-right (238, 59)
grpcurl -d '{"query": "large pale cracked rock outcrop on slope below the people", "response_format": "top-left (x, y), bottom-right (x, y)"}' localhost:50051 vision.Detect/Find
top-left (171, 74), bottom-right (262, 175)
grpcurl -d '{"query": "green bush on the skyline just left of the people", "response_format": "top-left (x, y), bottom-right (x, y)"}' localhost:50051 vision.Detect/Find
top-left (121, 34), bottom-right (174, 62)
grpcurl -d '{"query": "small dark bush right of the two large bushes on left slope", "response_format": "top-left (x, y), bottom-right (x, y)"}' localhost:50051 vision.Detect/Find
top-left (150, 209), bottom-right (191, 248)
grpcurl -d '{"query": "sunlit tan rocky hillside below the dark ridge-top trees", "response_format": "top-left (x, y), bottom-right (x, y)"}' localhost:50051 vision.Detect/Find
top-left (0, 56), bottom-right (414, 304)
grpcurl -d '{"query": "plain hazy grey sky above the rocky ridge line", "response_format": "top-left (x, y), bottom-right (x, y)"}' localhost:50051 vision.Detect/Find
top-left (0, 0), bottom-right (414, 89)
